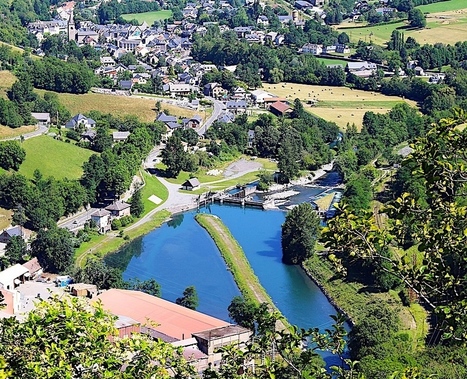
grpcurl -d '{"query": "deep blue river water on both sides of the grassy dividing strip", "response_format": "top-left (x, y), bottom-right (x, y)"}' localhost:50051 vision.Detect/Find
top-left (106, 174), bottom-right (348, 364)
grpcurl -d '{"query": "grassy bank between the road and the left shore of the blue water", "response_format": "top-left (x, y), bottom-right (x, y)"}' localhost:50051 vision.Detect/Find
top-left (74, 172), bottom-right (170, 267)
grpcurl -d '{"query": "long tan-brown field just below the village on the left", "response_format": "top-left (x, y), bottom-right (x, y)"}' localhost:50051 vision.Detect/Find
top-left (37, 90), bottom-right (196, 122)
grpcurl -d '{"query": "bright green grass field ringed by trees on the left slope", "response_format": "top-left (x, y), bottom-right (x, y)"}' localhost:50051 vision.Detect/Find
top-left (19, 136), bottom-right (94, 179)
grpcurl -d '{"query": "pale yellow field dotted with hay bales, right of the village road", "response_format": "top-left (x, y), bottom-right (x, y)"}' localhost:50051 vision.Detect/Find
top-left (263, 83), bottom-right (416, 129)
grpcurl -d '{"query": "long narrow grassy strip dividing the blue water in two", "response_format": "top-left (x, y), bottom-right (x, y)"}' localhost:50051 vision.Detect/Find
top-left (195, 213), bottom-right (288, 324)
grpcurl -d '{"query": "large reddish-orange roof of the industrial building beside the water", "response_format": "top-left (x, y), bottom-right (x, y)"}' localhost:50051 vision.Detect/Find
top-left (97, 289), bottom-right (230, 340)
